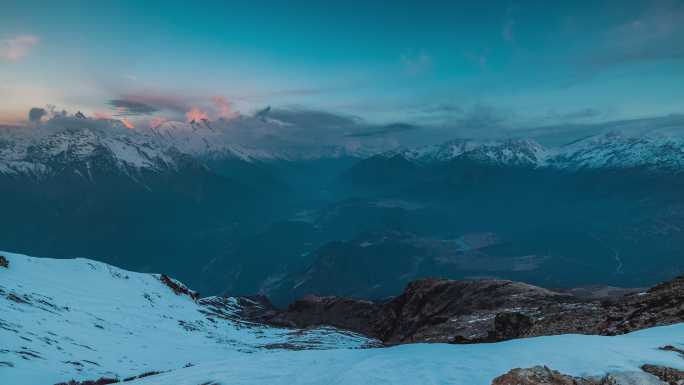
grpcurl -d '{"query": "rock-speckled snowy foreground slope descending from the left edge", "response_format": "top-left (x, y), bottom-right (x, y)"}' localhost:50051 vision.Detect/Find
top-left (0, 252), bottom-right (374, 385)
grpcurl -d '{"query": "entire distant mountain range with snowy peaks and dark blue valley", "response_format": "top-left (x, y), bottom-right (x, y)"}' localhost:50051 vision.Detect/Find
top-left (0, 117), bottom-right (684, 306)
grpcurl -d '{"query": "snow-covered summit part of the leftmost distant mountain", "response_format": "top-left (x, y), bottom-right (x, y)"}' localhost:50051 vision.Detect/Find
top-left (0, 119), bottom-right (181, 180)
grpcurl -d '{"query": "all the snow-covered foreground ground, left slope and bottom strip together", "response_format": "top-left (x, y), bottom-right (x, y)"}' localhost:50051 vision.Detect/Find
top-left (0, 252), bottom-right (684, 385)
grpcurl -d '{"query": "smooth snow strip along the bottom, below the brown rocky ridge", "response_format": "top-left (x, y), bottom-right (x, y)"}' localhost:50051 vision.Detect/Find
top-left (124, 324), bottom-right (684, 385)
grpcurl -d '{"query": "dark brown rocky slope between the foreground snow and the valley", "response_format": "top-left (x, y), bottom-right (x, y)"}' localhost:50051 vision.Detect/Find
top-left (267, 276), bottom-right (684, 344)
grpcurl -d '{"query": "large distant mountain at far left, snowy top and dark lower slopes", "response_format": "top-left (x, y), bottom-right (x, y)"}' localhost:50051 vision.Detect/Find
top-left (0, 118), bottom-right (283, 283)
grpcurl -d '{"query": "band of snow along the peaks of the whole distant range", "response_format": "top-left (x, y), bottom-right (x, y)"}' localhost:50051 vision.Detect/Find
top-left (5, 118), bottom-right (684, 177)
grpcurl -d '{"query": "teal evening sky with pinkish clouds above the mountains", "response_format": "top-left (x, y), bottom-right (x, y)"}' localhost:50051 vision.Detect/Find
top-left (0, 0), bottom-right (684, 138)
